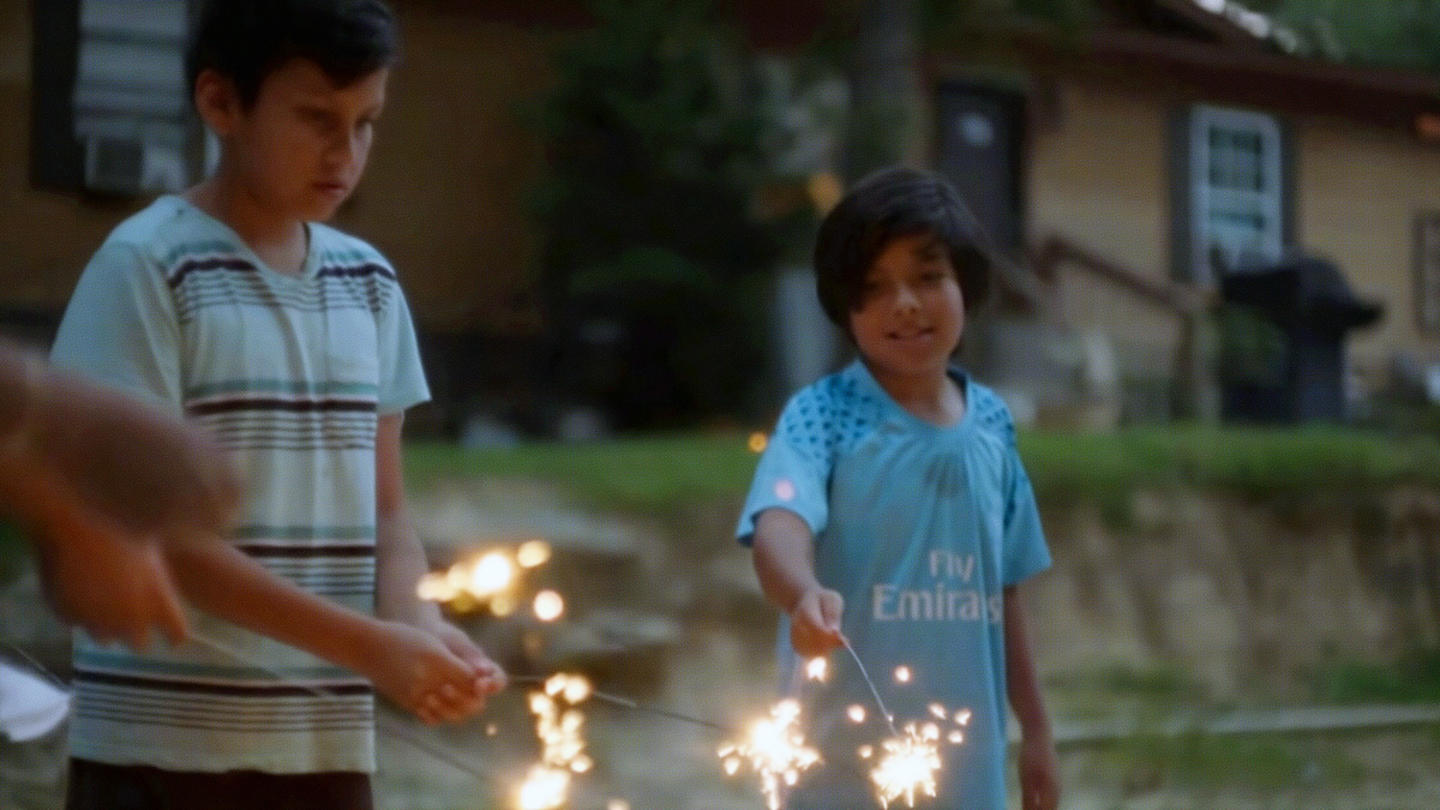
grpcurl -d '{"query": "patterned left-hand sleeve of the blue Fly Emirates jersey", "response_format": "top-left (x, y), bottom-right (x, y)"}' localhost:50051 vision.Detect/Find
top-left (736, 395), bottom-right (831, 546)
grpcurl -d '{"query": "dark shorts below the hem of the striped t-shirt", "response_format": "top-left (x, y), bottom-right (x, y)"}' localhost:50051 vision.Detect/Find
top-left (65, 760), bottom-right (374, 810)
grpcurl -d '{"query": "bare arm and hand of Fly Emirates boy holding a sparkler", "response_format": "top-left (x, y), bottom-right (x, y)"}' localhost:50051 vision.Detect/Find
top-left (755, 509), bottom-right (845, 657)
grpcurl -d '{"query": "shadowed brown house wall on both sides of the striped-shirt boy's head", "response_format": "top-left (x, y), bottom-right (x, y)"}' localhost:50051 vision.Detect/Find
top-left (0, 0), bottom-right (552, 331)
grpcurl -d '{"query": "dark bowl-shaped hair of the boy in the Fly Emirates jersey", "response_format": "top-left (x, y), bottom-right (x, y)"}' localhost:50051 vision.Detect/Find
top-left (815, 167), bottom-right (991, 333)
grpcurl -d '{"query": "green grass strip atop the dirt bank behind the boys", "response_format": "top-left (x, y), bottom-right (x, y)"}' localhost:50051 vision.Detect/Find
top-left (406, 425), bottom-right (1440, 509)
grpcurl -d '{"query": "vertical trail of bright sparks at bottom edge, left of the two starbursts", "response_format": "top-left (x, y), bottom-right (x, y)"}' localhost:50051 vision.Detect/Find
top-left (516, 672), bottom-right (595, 810)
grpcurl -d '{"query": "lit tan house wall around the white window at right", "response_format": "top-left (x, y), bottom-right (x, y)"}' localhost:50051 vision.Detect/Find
top-left (1027, 69), bottom-right (1440, 382)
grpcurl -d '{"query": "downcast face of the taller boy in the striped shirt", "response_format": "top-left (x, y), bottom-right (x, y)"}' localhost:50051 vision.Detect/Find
top-left (207, 59), bottom-right (390, 221)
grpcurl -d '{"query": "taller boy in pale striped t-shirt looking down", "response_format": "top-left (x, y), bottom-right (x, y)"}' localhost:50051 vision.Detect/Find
top-left (53, 0), bottom-right (504, 810)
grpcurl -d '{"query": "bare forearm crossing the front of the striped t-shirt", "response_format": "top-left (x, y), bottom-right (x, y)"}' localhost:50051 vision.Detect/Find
top-left (166, 540), bottom-right (376, 672)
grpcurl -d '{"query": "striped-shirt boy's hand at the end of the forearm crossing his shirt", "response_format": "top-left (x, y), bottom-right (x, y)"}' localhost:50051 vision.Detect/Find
top-left (361, 621), bottom-right (485, 725)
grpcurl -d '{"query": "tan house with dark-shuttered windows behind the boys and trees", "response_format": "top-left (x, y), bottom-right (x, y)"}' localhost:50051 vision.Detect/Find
top-left (8, 0), bottom-right (1440, 426)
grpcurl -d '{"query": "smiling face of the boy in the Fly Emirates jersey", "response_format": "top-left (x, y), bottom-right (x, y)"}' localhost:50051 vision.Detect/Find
top-left (850, 233), bottom-right (965, 378)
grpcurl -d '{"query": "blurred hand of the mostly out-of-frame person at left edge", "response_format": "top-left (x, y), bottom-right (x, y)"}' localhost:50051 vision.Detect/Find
top-left (37, 513), bottom-right (189, 650)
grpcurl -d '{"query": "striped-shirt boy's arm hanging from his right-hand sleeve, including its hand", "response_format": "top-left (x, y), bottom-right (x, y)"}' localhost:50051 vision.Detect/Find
top-left (374, 414), bottom-right (505, 722)
